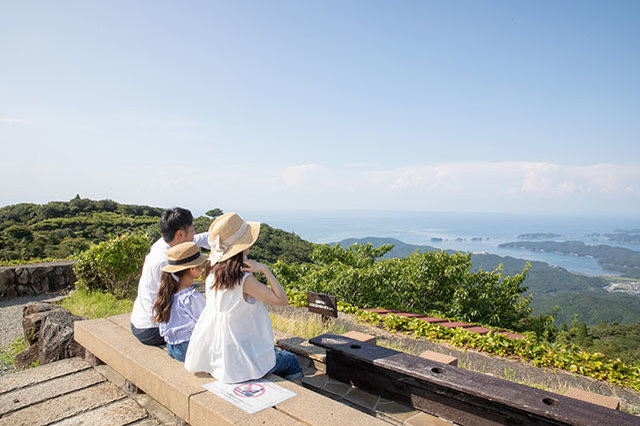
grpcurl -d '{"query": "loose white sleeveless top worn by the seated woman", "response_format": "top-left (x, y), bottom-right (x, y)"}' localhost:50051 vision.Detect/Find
top-left (184, 274), bottom-right (276, 383)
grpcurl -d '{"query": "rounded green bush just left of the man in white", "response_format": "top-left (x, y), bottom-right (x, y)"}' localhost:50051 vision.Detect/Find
top-left (73, 234), bottom-right (150, 299)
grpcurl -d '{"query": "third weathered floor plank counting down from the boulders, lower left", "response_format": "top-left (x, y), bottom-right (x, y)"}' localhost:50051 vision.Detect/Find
top-left (0, 382), bottom-right (126, 426)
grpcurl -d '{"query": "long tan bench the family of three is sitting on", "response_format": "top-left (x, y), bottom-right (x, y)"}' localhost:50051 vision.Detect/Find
top-left (74, 314), bottom-right (386, 426)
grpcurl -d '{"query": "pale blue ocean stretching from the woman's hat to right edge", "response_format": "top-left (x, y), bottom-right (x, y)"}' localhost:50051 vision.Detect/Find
top-left (239, 210), bottom-right (640, 275)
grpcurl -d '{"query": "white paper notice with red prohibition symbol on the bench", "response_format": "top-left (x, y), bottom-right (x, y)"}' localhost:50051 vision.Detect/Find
top-left (202, 379), bottom-right (296, 414)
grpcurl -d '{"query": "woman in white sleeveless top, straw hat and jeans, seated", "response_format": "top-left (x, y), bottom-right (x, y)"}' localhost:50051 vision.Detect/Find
top-left (184, 213), bottom-right (302, 383)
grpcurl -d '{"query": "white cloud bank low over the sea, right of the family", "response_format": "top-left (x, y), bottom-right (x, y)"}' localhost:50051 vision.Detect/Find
top-left (262, 162), bottom-right (640, 213)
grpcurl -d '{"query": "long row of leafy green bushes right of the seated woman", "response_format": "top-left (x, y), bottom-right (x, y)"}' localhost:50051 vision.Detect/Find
top-left (273, 244), bottom-right (550, 333)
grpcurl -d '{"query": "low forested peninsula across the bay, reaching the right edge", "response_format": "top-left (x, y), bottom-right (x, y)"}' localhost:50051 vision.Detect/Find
top-left (498, 241), bottom-right (640, 278)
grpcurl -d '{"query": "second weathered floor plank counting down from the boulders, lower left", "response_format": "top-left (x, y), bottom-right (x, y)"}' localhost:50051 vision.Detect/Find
top-left (0, 369), bottom-right (105, 416)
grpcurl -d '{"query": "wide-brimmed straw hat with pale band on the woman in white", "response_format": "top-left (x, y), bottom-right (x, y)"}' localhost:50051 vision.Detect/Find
top-left (209, 213), bottom-right (260, 265)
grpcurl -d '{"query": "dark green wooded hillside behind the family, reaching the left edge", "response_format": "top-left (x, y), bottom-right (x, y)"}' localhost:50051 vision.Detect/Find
top-left (0, 196), bottom-right (313, 263)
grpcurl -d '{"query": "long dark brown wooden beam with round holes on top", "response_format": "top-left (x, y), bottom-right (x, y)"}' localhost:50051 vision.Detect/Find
top-left (310, 334), bottom-right (640, 425)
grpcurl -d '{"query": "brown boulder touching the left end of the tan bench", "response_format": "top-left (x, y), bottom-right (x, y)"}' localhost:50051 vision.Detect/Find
top-left (37, 309), bottom-right (86, 365)
